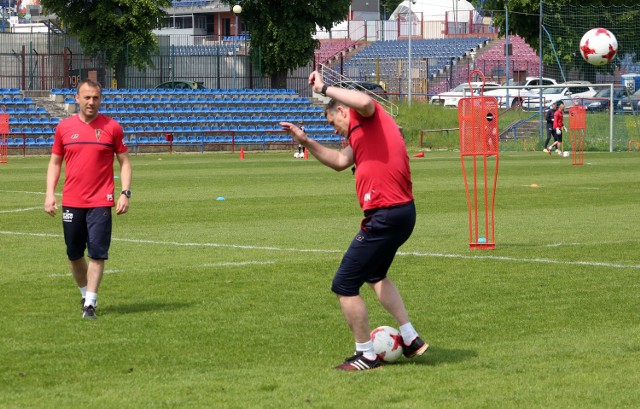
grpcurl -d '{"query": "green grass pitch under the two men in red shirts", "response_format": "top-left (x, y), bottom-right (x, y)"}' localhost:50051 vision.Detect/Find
top-left (0, 151), bottom-right (640, 408)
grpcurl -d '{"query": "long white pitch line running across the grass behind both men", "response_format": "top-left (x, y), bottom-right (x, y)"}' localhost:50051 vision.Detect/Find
top-left (0, 231), bottom-right (640, 269)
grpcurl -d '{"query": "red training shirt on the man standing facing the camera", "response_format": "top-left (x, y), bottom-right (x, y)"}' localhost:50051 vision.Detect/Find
top-left (52, 114), bottom-right (127, 208)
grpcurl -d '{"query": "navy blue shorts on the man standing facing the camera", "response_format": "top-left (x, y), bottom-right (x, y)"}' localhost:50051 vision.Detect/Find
top-left (62, 206), bottom-right (111, 260)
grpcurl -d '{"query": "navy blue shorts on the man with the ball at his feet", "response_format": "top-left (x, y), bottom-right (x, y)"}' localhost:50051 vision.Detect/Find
top-left (331, 202), bottom-right (416, 296)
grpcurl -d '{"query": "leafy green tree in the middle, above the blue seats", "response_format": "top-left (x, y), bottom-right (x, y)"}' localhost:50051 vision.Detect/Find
top-left (224, 0), bottom-right (351, 88)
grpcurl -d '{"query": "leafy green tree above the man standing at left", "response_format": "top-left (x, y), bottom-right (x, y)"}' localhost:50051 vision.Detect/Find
top-left (41, 0), bottom-right (171, 85)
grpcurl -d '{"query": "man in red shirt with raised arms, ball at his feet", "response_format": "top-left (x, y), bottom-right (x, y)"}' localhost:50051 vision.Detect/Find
top-left (280, 71), bottom-right (429, 371)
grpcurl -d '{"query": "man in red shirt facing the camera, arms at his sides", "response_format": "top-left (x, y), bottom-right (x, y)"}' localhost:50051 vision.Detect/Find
top-left (44, 80), bottom-right (131, 318)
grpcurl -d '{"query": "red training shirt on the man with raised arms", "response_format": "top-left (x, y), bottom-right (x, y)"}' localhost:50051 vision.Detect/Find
top-left (348, 102), bottom-right (413, 210)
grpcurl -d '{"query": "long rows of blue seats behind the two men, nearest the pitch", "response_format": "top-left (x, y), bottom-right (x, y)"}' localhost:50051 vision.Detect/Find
top-left (38, 88), bottom-right (340, 152)
